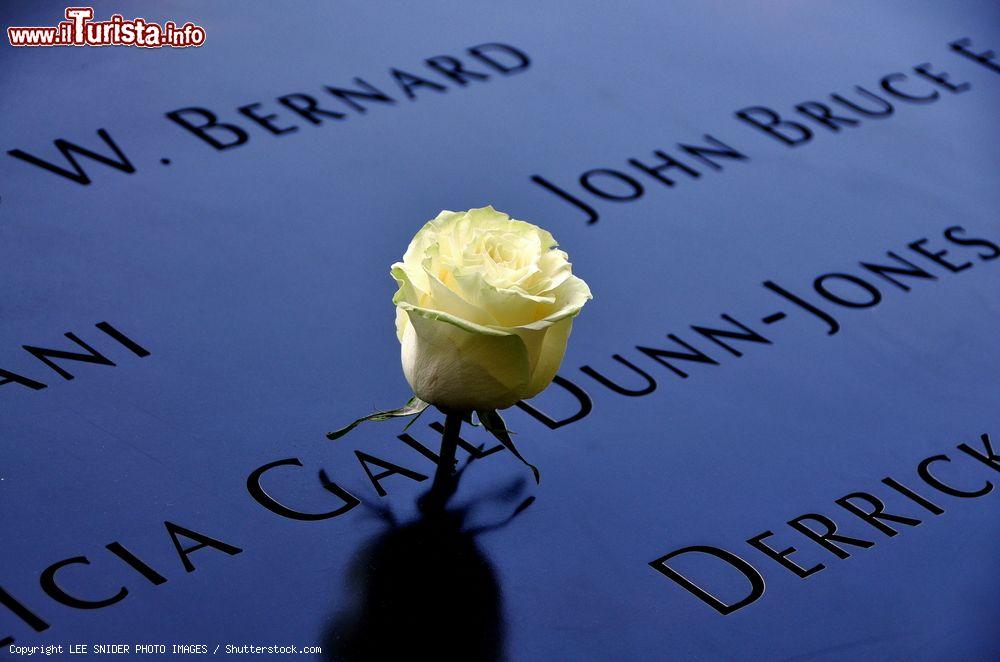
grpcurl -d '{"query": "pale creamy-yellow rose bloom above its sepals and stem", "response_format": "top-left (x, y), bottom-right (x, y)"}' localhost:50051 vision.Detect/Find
top-left (392, 207), bottom-right (593, 412)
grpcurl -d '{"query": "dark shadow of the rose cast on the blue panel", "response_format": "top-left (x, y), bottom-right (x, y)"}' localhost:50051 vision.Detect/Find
top-left (322, 456), bottom-right (535, 660)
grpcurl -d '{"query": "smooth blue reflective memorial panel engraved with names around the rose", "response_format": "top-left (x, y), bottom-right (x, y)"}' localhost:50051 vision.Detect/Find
top-left (0, 2), bottom-right (1000, 660)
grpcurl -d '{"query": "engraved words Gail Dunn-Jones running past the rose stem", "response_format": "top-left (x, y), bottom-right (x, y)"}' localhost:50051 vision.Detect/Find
top-left (247, 226), bottom-right (1000, 521)
